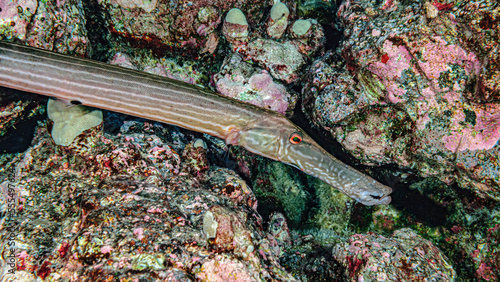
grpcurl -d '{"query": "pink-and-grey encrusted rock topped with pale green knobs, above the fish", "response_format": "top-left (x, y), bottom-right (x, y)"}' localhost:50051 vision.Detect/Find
top-left (214, 2), bottom-right (326, 113)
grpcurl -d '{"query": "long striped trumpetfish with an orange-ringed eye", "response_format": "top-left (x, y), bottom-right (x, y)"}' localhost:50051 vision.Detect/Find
top-left (0, 41), bottom-right (392, 205)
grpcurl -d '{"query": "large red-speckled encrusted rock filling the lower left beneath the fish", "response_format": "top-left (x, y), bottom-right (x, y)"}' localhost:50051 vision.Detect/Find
top-left (0, 116), bottom-right (296, 281)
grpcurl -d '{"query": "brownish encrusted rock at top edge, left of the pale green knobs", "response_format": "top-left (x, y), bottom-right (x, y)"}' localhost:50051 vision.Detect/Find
top-left (99, 0), bottom-right (265, 55)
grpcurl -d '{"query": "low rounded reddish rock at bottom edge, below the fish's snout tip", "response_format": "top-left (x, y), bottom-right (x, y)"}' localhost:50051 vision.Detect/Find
top-left (333, 229), bottom-right (455, 282)
